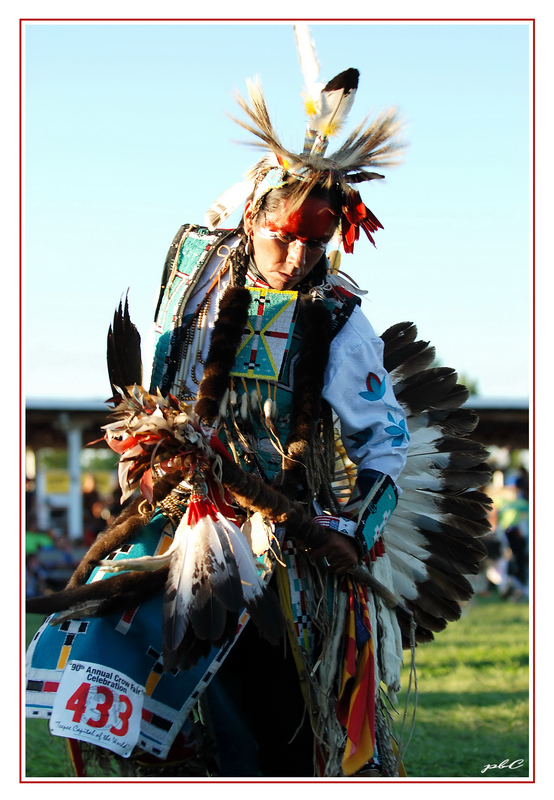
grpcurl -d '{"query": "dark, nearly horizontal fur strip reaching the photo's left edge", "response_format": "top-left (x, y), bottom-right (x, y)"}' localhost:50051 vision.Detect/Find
top-left (26, 567), bottom-right (169, 617)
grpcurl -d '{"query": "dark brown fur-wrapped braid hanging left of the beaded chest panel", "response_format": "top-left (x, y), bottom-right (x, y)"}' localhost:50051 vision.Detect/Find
top-left (194, 286), bottom-right (251, 422)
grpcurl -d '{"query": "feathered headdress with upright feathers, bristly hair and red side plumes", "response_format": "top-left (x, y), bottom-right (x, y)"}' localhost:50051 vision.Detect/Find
top-left (206, 25), bottom-right (402, 253)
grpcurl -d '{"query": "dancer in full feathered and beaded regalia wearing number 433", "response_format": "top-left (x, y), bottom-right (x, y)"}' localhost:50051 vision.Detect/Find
top-left (27, 27), bottom-right (488, 777)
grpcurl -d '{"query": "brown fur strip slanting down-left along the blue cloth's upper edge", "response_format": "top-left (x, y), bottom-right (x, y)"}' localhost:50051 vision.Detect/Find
top-left (67, 473), bottom-right (183, 589)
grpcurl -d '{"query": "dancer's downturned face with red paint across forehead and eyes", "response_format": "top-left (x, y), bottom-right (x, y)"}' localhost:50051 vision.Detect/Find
top-left (244, 197), bottom-right (338, 291)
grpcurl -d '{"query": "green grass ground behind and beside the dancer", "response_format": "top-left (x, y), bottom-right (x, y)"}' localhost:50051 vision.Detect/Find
top-left (26, 597), bottom-right (529, 779)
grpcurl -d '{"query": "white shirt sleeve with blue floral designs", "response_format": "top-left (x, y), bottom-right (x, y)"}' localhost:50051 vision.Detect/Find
top-left (323, 307), bottom-right (409, 481)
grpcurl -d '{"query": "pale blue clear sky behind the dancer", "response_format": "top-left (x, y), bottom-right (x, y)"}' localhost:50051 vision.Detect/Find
top-left (24, 22), bottom-right (530, 399)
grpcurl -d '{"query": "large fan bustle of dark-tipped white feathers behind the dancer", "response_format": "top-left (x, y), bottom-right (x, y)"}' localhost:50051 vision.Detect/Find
top-left (381, 322), bottom-right (491, 647)
